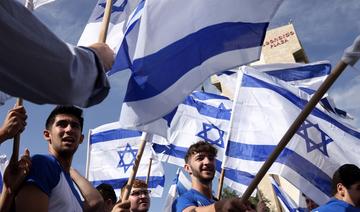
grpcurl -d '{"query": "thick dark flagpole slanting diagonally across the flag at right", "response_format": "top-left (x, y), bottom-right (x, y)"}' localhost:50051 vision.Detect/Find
top-left (241, 61), bottom-right (347, 201)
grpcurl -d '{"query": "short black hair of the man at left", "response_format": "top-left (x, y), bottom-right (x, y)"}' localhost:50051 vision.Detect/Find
top-left (45, 105), bottom-right (84, 130)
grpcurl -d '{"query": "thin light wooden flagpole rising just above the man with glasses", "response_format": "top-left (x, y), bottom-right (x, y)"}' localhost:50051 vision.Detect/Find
top-left (121, 132), bottom-right (147, 202)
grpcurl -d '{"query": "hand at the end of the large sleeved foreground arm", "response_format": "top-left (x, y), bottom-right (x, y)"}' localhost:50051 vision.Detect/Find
top-left (89, 43), bottom-right (115, 71)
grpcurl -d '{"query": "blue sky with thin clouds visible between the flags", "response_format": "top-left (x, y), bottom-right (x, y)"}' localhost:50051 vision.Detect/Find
top-left (0, 0), bottom-right (360, 211)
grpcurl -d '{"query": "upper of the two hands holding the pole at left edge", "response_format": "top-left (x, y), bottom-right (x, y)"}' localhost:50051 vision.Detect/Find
top-left (0, 106), bottom-right (27, 143)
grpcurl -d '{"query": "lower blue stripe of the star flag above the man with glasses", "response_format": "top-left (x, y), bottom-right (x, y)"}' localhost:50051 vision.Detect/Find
top-left (91, 176), bottom-right (165, 189)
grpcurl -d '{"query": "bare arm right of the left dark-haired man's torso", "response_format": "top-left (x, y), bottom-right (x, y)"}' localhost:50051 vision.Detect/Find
top-left (70, 168), bottom-right (104, 212)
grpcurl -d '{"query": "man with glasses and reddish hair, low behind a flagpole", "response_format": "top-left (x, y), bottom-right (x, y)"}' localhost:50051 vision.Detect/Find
top-left (121, 179), bottom-right (150, 212)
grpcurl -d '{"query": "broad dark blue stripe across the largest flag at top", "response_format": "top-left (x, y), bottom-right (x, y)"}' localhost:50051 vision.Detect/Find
top-left (119, 22), bottom-right (269, 102)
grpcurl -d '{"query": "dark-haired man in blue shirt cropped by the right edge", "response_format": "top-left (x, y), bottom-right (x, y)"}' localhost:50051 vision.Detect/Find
top-left (314, 164), bottom-right (360, 212)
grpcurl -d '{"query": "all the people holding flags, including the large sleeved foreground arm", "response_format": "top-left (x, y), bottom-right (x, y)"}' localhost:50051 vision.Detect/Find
top-left (0, 0), bottom-right (360, 212)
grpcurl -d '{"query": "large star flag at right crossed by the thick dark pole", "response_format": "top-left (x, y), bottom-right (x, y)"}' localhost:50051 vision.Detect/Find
top-left (223, 67), bottom-right (360, 204)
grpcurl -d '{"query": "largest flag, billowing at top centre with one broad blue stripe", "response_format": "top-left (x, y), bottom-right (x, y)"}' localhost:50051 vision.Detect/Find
top-left (110, 0), bottom-right (282, 128)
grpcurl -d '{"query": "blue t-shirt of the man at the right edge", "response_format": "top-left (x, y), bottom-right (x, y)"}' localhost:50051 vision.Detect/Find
top-left (313, 198), bottom-right (360, 212)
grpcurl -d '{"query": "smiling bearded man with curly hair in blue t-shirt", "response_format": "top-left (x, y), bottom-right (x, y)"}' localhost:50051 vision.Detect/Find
top-left (172, 141), bottom-right (247, 212)
